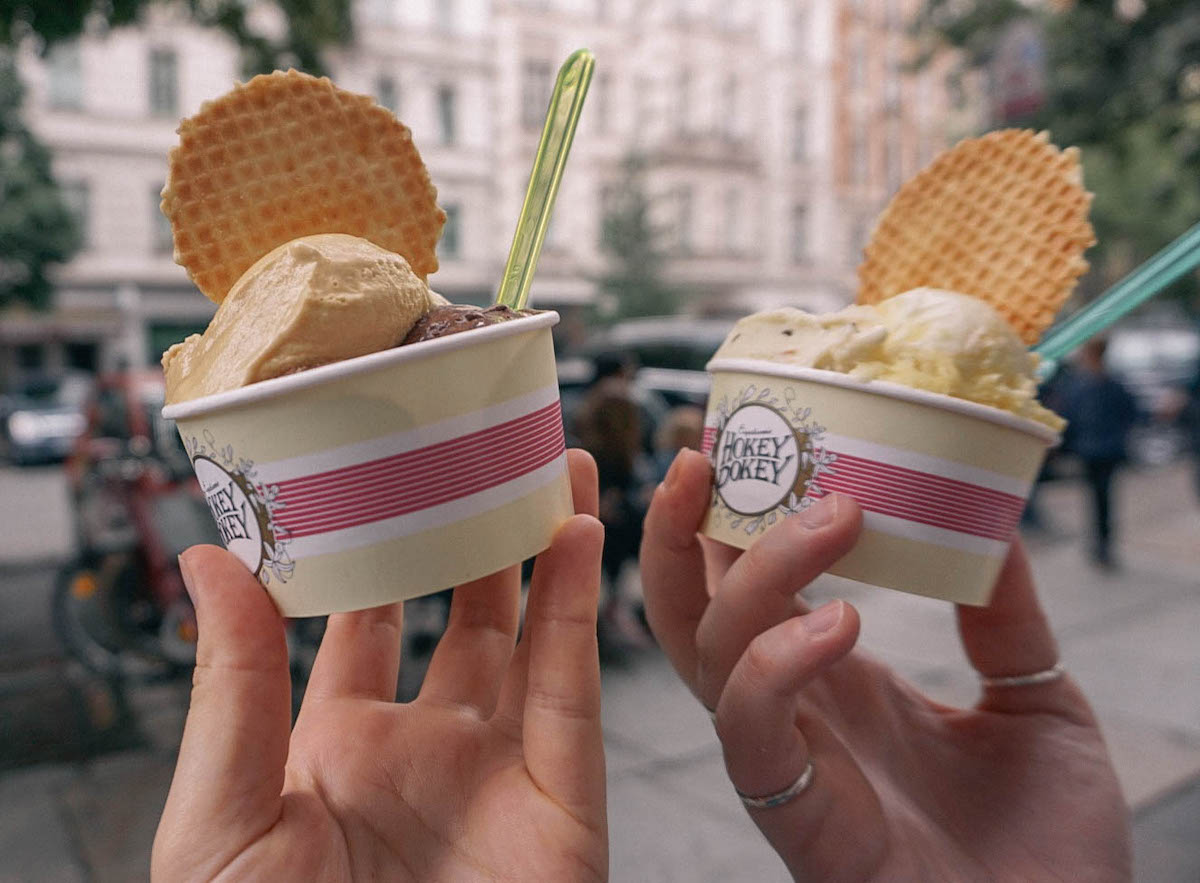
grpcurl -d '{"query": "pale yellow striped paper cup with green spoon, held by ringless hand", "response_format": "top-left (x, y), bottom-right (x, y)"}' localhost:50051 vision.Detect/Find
top-left (163, 312), bottom-right (572, 617)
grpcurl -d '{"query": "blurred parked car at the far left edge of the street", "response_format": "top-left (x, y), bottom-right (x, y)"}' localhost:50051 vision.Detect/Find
top-left (0, 374), bottom-right (91, 465)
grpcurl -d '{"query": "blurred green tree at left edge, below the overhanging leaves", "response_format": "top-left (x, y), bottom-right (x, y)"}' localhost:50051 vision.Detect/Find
top-left (0, 49), bottom-right (79, 308)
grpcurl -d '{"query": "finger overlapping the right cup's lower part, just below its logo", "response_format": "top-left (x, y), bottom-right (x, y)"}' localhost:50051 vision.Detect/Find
top-left (696, 494), bottom-right (862, 708)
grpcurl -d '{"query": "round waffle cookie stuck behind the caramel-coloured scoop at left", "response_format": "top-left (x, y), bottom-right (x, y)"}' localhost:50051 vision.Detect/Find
top-left (162, 71), bottom-right (445, 304)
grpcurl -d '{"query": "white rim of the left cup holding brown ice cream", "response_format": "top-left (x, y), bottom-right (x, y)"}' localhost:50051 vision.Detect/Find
top-left (162, 307), bottom-right (558, 420)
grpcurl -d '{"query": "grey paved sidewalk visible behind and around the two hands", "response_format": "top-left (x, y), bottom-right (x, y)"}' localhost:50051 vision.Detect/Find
top-left (0, 458), bottom-right (1200, 883)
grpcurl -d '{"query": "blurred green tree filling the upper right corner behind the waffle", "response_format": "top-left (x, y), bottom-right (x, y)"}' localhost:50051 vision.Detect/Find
top-left (914, 0), bottom-right (1200, 307)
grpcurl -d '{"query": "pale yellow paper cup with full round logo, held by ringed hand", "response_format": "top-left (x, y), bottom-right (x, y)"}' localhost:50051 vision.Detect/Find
top-left (703, 359), bottom-right (1058, 605)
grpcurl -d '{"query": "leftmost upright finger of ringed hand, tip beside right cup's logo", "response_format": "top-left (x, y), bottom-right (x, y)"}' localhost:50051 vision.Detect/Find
top-left (640, 449), bottom-right (713, 695)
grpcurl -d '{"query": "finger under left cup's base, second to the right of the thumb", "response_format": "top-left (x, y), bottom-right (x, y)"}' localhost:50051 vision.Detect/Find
top-left (420, 566), bottom-right (521, 717)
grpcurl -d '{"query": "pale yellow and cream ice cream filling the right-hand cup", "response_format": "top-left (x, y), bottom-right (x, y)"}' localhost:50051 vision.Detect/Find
top-left (716, 288), bottom-right (1064, 430)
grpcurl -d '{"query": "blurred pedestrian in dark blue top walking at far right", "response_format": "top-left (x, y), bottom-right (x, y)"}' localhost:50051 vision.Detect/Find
top-left (1058, 338), bottom-right (1138, 569)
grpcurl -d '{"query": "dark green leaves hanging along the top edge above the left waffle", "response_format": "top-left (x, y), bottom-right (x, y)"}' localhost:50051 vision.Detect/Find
top-left (0, 0), bottom-right (353, 74)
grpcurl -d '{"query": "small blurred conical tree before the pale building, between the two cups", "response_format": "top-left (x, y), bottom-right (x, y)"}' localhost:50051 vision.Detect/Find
top-left (600, 155), bottom-right (678, 319)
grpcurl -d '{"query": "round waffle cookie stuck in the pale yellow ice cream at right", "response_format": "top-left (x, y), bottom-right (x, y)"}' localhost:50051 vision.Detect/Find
top-left (857, 128), bottom-right (1096, 343)
